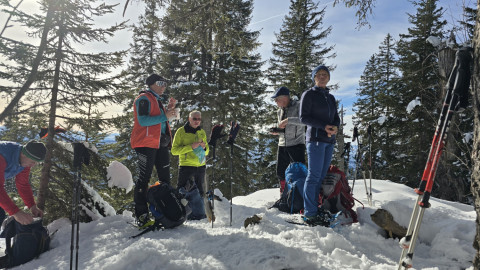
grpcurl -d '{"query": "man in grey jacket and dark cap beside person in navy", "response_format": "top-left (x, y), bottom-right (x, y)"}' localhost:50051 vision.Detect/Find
top-left (271, 86), bottom-right (305, 193)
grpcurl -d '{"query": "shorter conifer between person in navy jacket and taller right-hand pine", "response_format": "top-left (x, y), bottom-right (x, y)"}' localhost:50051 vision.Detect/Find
top-left (354, 34), bottom-right (401, 179)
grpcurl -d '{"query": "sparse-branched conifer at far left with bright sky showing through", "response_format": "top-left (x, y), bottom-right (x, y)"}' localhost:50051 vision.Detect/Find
top-left (1, 1), bottom-right (125, 215)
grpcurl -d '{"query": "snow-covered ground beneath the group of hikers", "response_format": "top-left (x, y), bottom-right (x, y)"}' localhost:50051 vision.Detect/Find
top-left (7, 180), bottom-right (476, 270)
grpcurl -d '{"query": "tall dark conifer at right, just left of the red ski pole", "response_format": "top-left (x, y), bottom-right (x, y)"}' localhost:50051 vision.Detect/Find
top-left (395, 0), bottom-right (446, 186)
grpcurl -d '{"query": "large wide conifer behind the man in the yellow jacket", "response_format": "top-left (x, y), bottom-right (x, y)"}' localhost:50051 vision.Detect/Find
top-left (158, 0), bottom-right (270, 196)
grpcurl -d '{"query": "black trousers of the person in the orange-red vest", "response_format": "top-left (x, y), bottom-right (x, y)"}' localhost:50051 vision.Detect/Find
top-left (133, 147), bottom-right (170, 217)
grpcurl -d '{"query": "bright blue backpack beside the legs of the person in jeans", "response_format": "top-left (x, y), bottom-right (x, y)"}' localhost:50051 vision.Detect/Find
top-left (272, 162), bottom-right (308, 214)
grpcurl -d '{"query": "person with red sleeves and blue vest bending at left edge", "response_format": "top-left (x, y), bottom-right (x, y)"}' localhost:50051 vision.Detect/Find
top-left (0, 141), bottom-right (47, 225)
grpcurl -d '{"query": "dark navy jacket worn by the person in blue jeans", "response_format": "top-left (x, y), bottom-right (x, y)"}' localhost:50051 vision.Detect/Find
top-left (300, 86), bottom-right (340, 144)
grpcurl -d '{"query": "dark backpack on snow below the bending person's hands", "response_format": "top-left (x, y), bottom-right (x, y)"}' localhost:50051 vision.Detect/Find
top-left (0, 217), bottom-right (50, 268)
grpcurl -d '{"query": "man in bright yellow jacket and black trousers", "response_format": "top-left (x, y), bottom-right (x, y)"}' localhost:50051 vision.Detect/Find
top-left (171, 111), bottom-right (210, 219)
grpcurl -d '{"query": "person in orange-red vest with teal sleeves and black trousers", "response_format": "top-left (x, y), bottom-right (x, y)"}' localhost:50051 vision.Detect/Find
top-left (130, 74), bottom-right (176, 227)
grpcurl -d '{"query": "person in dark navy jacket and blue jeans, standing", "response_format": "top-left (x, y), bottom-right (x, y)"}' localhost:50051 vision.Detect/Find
top-left (299, 65), bottom-right (340, 225)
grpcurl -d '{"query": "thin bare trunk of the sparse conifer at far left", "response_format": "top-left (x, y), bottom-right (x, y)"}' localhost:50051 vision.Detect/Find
top-left (37, 10), bottom-right (65, 209)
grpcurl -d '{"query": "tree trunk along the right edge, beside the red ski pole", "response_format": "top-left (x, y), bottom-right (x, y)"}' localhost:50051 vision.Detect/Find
top-left (471, 0), bottom-right (480, 269)
